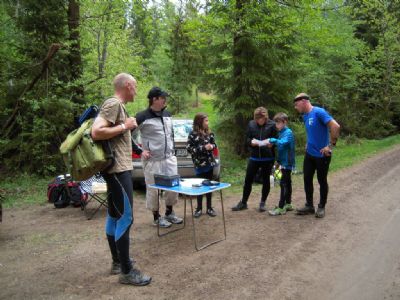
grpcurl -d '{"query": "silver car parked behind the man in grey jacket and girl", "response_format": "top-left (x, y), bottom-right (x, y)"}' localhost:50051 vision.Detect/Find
top-left (132, 119), bottom-right (221, 185)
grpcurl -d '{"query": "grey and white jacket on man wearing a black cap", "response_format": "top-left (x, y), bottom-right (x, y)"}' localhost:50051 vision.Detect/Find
top-left (133, 107), bottom-right (175, 160)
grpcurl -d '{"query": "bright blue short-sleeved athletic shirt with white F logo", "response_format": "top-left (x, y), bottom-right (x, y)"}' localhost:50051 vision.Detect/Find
top-left (303, 106), bottom-right (333, 157)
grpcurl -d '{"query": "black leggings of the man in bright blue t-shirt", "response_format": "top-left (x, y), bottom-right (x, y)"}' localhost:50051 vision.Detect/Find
top-left (303, 153), bottom-right (331, 208)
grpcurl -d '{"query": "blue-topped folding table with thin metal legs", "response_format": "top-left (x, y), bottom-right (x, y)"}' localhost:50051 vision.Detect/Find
top-left (148, 182), bottom-right (231, 251)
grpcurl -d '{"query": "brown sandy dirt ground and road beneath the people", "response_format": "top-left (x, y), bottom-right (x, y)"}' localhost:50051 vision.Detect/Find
top-left (0, 147), bottom-right (400, 300)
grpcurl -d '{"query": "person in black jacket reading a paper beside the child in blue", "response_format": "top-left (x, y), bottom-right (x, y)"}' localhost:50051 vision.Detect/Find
top-left (232, 107), bottom-right (277, 212)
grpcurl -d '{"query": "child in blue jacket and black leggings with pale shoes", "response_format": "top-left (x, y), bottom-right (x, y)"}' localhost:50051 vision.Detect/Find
top-left (268, 113), bottom-right (295, 216)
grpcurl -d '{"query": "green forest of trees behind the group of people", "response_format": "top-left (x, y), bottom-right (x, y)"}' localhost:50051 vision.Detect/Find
top-left (0, 0), bottom-right (400, 175)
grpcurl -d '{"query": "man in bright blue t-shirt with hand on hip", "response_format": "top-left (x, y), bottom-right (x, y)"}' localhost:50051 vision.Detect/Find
top-left (294, 93), bottom-right (340, 218)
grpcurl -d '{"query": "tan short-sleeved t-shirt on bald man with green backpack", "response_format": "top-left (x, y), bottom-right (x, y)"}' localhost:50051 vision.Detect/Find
top-left (99, 97), bottom-right (132, 173)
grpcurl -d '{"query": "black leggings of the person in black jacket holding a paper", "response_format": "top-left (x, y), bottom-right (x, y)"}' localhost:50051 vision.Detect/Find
top-left (242, 159), bottom-right (274, 203)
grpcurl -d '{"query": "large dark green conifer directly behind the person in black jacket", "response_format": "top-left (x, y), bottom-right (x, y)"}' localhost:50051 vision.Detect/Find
top-left (205, 0), bottom-right (296, 155)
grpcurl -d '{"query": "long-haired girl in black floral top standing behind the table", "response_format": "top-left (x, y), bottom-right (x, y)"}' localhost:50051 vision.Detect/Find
top-left (186, 113), bottom-right (217, 218)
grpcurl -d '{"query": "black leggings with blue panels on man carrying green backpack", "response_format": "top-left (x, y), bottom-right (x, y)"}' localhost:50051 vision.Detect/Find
top-left (103, 171), bottom-right (133, 274)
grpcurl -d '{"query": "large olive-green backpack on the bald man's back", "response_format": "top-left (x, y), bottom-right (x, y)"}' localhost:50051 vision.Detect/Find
top-left (60, 118), bottom-right (114, 181)
